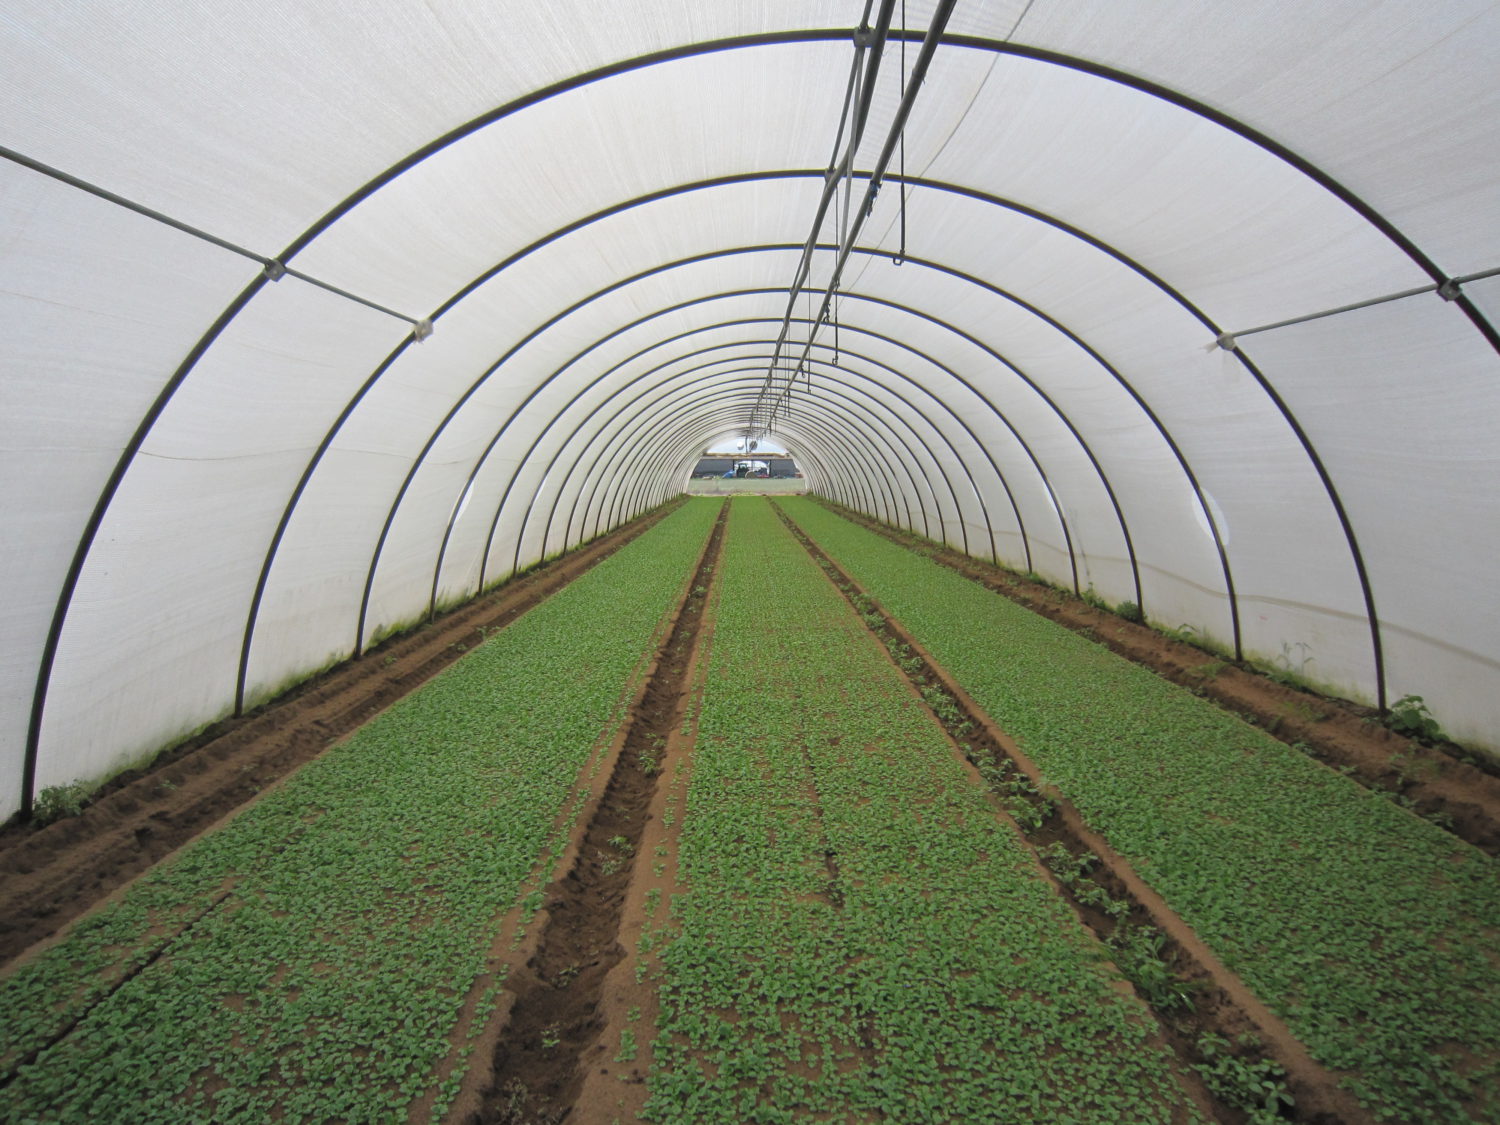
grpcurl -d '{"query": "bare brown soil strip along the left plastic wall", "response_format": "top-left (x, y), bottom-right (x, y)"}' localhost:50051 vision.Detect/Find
top-left (0, 506), bottom-right (675, 968)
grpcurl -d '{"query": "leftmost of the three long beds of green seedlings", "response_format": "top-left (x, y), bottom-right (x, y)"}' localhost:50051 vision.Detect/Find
top-left (0, 503), bottom-right (717, 1122)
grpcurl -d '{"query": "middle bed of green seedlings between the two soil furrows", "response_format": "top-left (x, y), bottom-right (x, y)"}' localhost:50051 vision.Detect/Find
top-left (642, 498), bottom-right (1203, 1125)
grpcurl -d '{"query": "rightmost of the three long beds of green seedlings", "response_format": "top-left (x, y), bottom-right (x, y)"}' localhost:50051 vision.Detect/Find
top-left (783, 500), bottom-right (1500, 1122)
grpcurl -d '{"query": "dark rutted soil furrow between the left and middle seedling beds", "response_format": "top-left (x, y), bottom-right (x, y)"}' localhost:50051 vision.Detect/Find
top-left (468, 504), bottom-right (729, 1125)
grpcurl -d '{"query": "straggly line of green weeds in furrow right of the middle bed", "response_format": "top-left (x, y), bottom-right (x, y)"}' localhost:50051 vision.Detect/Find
top-left (804, 558), bottom-right (1293, 1125)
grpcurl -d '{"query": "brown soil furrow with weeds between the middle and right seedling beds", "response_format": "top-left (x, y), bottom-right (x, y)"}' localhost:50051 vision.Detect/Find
top-left (773, 504), bottom-right (1376, 1125)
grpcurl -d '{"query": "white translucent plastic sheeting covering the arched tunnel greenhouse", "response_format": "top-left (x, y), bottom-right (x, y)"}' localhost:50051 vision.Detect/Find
top-left (0, 0), bottom-right (1500, 816)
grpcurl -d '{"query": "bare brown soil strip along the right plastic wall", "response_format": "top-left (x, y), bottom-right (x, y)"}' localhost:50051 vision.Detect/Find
top-left (821, 501), bottom-right (1500, 855)
